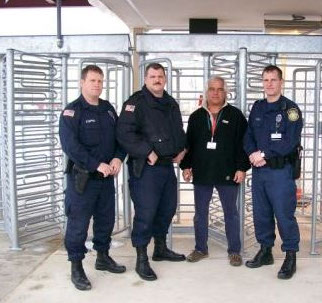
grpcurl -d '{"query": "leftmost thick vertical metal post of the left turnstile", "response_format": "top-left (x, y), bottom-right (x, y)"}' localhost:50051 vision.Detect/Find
top-left (6, 49), bottom-right (20, 250)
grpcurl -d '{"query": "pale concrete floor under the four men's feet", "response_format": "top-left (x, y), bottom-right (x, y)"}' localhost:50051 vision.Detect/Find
top-left (0, 234), bottom-right (322, 303)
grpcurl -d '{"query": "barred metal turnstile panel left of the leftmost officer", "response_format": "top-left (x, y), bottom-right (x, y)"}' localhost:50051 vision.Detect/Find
top-left (2, 51), bottom-right (64, 248)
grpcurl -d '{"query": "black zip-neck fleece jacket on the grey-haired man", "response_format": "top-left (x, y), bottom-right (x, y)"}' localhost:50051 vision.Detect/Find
top-left (180, 104), bottom-right (250, 185)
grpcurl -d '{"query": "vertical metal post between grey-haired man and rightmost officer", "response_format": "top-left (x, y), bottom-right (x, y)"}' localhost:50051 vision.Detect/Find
top-left (238, 47), bottom-right (247, 253)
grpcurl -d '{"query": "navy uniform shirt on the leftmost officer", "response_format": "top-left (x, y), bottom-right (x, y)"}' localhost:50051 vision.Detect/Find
top-left (59, 95), bottom-right (125, 172)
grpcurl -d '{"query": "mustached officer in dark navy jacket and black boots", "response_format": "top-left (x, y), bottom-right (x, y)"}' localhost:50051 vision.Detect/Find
top-left (117, 63), bottom-right (185, 281)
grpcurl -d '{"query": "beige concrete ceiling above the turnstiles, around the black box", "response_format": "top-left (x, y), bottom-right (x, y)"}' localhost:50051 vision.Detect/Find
top-left (97, 0), bottom-right (322, 32)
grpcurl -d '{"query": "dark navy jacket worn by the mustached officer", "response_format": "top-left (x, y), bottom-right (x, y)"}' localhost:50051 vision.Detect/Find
top-left (117, 86), bottom-right (185, 171)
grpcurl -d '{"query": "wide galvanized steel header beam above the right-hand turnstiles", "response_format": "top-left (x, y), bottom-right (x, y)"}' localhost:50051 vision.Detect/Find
top-left (136, 34), bottom-right (322, 54)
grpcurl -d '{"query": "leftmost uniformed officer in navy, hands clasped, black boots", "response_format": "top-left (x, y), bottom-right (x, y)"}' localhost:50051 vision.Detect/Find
top-left (59, 65), bottom-right (125, 290)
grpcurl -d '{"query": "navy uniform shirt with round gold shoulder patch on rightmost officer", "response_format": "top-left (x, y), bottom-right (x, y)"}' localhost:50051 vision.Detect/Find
top-left (244, 96), bottom-right (303, 159)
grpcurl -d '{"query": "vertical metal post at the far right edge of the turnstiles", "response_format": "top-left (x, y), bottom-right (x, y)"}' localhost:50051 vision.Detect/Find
top-left (311, 61), bottom-right (322, 255)
